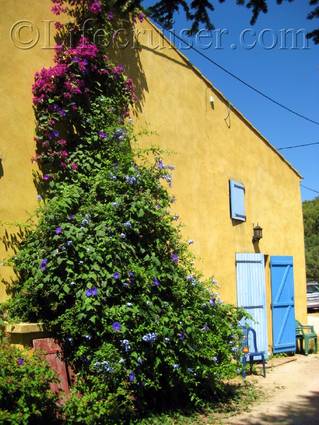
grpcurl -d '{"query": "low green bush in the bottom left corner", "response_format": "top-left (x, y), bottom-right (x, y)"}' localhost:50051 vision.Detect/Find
top-left (0, 345), bottom-right (58, 425)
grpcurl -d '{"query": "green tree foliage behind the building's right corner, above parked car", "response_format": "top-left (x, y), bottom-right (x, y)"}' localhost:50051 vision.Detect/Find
top-left (303, 198), bottom-right (319, 281)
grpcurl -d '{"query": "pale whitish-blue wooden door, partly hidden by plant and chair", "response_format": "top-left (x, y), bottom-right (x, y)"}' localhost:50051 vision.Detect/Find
top-left (236, 254), bottom-right (268, 357)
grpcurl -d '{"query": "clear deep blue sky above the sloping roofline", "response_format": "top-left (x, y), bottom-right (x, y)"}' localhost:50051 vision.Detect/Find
top-left (144, 0), bottom-right (319, 200)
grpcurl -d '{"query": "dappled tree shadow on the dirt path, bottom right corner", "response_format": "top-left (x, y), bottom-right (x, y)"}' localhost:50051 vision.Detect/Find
top-left (236, 391), bottom-right (319, 425)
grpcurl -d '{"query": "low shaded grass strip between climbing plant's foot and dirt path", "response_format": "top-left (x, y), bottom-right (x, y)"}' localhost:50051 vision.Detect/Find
top-left (135, 382), bottom-right (264, 425)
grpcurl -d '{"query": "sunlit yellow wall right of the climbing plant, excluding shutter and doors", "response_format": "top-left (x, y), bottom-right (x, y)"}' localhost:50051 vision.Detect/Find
top-left (124, 22), bottom-right (307, 332)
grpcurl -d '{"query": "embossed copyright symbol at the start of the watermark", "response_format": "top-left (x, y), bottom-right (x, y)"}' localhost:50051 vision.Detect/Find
top-left (10, 20), bottom-right (40, 50)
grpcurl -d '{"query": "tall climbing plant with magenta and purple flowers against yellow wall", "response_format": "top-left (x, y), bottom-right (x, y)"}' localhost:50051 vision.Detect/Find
top-left (9, 0), bottom-right (246, 424)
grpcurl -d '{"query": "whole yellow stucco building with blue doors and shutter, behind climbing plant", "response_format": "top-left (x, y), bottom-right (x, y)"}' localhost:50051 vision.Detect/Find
top-left (0, 0), bottom-right (306, 352)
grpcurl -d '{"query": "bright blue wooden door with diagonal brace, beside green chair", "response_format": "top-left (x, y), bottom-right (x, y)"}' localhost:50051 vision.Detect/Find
top-left (270, 257), bottom-right (296, 353)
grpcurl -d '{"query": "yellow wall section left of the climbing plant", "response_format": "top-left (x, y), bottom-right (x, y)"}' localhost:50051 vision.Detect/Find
top-left (0, 0), bottom-right (56, 300)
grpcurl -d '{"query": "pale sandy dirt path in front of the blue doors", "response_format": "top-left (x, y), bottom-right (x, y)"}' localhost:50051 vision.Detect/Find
top-left (223, 354), bottom-right (319, 425)
